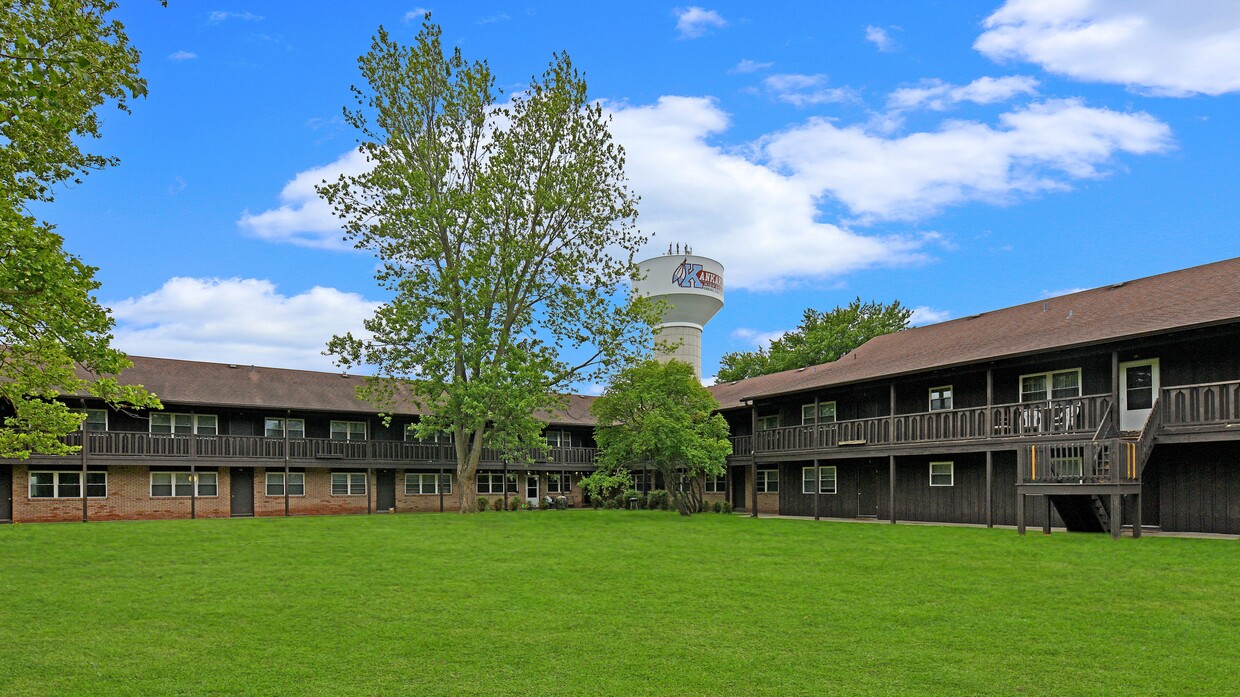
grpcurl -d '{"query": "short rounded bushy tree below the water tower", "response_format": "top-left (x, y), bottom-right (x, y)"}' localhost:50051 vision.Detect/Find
top-left (590, 360), bottom-right (732, 516)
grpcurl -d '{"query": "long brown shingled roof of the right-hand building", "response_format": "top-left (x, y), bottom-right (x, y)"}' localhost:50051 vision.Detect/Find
top-left (712, 258), bottom-right (1240, 409)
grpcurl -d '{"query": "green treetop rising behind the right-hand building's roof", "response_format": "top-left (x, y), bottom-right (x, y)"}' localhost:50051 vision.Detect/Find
top-left (715, 298), bottom-right (913, 382)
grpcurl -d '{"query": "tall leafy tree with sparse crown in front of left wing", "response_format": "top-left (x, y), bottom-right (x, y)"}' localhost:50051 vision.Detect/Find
top-left (319, 16), bottom-right (657, 513)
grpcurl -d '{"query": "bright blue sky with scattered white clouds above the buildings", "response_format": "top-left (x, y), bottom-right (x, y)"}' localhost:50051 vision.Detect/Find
top-left (38, 0), bottom-right (1240, 384)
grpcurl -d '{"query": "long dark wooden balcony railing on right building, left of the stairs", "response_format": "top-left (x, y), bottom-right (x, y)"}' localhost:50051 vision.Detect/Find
top-left (754, 394), bottom-right (1111, 453)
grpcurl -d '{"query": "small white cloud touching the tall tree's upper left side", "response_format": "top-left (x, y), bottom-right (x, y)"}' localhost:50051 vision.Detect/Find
top-left (237, 150), bottom-right (370, 249)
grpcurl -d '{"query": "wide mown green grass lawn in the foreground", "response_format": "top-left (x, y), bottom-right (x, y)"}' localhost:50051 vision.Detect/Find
top-left (0, 511), bottom-right (1240, 695)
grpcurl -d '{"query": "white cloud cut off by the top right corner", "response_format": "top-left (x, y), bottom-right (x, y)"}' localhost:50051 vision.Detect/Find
top-left (973, 0), bottom-right (1240, 97)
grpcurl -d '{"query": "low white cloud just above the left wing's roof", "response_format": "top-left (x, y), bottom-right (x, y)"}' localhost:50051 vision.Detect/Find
top-left (110, 278), bottom-right (378, 370)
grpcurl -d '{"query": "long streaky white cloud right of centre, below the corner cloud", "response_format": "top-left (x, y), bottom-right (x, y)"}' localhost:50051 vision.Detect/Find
top-left (763, 99), bottom-right (1171, 221)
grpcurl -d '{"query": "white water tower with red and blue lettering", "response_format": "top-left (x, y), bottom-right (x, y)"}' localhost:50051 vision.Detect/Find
top-left (634, 244), bottom-right (723, 377)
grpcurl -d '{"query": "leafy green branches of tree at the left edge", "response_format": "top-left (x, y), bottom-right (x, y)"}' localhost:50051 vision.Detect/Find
top-left (0, 0), bottom-right (159, 458)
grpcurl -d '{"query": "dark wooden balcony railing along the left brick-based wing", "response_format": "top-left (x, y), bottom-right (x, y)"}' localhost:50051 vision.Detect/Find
top-left (57, 430), bottom-right (596, 466)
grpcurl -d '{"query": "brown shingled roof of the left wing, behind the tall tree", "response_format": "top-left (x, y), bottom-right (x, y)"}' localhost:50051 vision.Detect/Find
top-left (106, 356), bottom-right (594, 425)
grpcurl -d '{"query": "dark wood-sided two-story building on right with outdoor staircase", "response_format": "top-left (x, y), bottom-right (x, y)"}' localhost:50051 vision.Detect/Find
top-left (714, 259), bottom-right (1240, 535)
